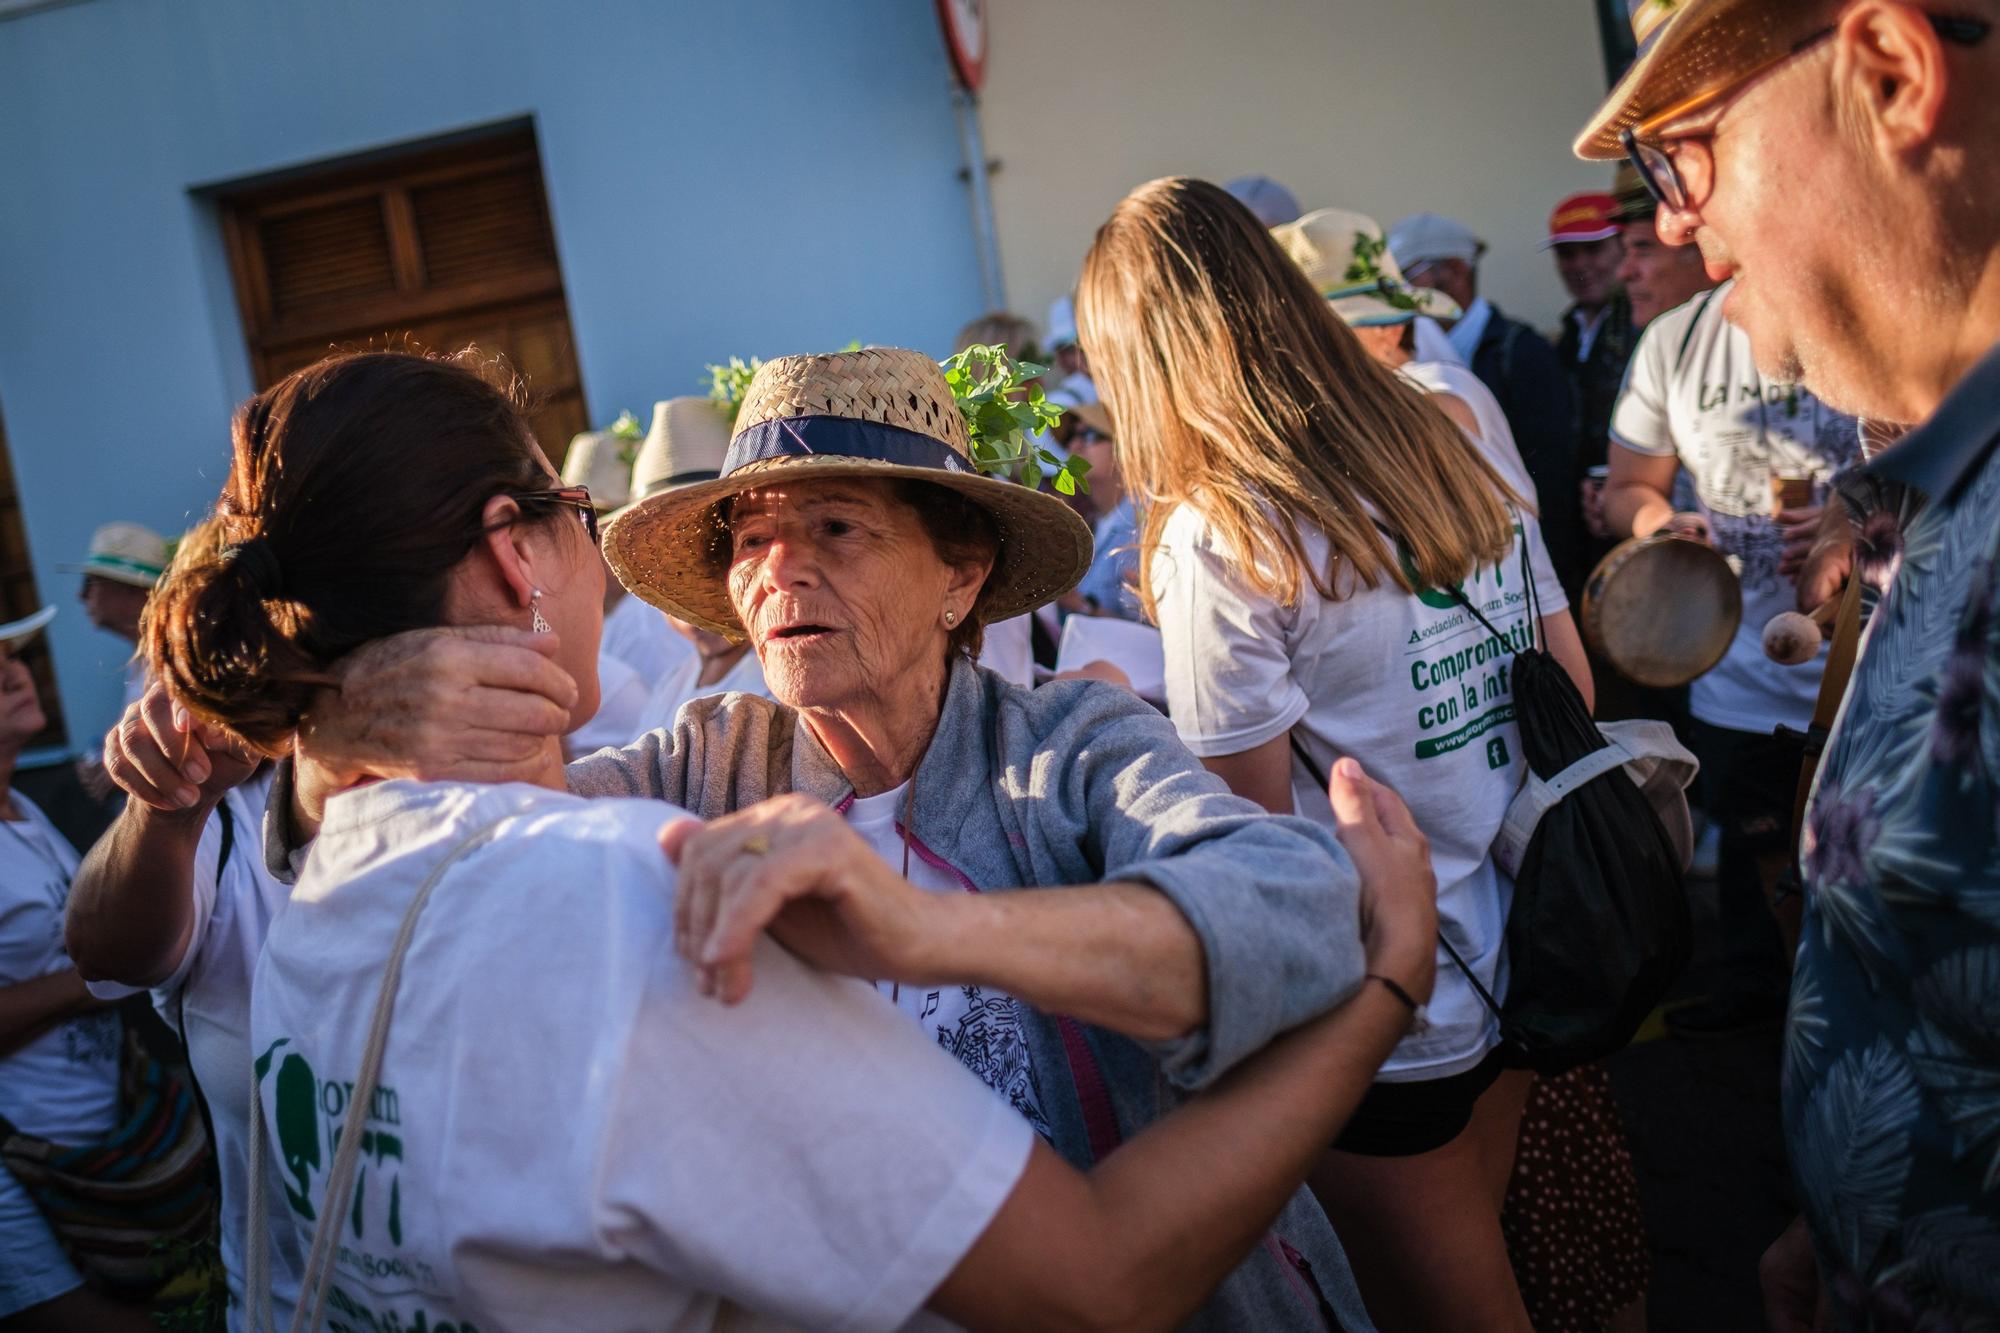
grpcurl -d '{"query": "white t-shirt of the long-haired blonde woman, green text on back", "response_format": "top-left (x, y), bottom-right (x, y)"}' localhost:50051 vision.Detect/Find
top-left (1152, 504), bottom-right (1568, 1083)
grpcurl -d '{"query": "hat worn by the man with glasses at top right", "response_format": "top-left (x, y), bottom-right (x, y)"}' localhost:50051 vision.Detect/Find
top-left (1576, 0), bottom-right (1828, 162)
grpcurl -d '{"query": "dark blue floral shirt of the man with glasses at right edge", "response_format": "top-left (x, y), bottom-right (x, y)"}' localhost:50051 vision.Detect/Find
top-left (1784, 348), bottom-right (2000, 1329)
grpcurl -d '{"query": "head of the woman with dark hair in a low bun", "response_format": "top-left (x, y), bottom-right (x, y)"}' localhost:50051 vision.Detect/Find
top-left (142, 352), bottom-right (604, 753)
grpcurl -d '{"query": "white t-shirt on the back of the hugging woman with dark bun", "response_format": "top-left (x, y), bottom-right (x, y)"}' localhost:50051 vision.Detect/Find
top-left (252, 783), bottom-right (1034, 1333)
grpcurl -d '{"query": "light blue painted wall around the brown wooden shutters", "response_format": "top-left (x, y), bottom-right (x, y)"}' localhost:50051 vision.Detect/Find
top-left (0, 0), bottom-right (980, 741)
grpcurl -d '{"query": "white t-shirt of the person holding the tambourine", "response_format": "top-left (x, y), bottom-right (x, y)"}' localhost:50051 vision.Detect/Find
top-left (1612, 284), bottom-right (1860, 735)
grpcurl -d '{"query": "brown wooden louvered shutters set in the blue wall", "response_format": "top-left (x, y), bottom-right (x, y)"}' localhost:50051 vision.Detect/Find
top-left (222, 130), bottom-right (586, 466)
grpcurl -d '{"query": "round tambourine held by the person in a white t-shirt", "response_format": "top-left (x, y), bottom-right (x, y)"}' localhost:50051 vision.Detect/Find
top-left (1582, 532), bottom-right (1744, 691)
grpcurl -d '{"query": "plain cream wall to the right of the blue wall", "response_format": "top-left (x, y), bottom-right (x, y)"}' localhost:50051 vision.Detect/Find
top-left (982, 0), bottom-right (1610, 342)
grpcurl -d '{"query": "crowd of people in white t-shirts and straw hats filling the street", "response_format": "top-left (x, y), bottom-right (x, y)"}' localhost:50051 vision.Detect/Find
top-left (0, 0), bottom-right (2000, 1333)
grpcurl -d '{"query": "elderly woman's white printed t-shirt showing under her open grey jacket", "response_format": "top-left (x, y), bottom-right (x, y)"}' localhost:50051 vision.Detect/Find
top-left (846, 783), bottom-right (1050, 1139)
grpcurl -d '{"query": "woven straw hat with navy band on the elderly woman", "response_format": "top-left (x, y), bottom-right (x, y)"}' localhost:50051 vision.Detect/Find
top-left (604, 348), bottom-right (1092, 638)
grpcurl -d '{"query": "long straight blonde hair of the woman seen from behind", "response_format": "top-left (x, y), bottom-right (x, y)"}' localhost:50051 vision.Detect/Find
top-left (1076, 176), bottom-right (1522, 614)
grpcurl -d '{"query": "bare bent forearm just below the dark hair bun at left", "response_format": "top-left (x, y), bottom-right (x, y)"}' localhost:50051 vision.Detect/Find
top-left (62, 801), bottom-right (214, 987)
